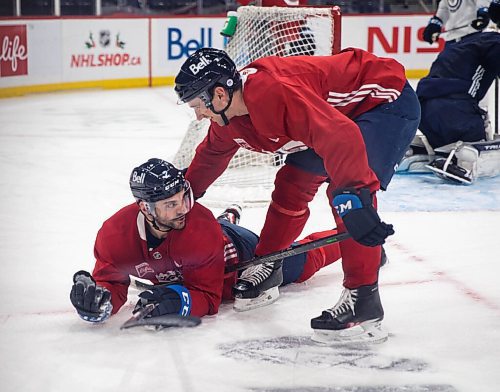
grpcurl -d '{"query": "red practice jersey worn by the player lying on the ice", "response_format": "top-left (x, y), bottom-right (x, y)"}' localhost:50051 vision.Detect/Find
top-left (92, 203), bottom-right (232, 317)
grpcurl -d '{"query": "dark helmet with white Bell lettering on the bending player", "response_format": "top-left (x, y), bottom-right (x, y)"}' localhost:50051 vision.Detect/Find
top-left (175, 48), bottom-right (241, 125)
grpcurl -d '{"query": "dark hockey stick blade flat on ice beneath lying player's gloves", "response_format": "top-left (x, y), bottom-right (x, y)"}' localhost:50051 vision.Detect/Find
top-left (120, 304), bottom-right (201, 331)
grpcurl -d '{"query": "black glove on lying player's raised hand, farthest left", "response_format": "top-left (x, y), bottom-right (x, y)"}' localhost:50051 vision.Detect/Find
top-left (69, 271), bottom-right (113, 323)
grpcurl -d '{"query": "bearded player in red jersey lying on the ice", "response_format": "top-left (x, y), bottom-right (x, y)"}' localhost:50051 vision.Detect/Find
top-left (70, 158), bottom-right (340, 322)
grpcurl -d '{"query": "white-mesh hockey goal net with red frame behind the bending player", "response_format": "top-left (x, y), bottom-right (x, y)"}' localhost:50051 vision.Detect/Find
top-left (173, 6), bottom-right (340, 206)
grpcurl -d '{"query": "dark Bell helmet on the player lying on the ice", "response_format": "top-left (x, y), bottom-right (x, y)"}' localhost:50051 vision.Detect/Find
top-left (129, 158), bottom-right (194, 222)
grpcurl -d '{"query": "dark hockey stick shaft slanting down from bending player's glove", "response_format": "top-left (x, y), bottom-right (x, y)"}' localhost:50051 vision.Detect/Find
top-left (225, 233), bottom-right (351, 273)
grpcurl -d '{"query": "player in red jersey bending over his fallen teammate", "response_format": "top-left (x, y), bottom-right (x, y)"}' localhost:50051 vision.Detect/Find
top-left (175, 48), bottom-right (420, 340)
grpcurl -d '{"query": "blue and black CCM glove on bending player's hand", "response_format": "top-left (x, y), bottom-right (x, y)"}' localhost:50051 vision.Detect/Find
top-left (333, 188), bottom-right (394, 246)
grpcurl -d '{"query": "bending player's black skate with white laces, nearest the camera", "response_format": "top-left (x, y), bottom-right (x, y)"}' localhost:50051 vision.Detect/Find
top-left (311, 283), bottom-right (388, 345)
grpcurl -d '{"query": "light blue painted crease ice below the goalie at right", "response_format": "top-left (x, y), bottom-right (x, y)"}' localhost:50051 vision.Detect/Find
top-left (377, 174), bottom-right (500, 212)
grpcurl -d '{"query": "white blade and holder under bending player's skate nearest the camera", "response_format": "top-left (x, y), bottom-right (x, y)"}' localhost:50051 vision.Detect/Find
top-left (311, 321), bottom-right (389, 346)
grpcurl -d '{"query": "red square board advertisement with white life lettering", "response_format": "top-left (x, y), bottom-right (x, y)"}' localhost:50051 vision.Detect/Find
top-left (0, 25), bottom-right (28, 77)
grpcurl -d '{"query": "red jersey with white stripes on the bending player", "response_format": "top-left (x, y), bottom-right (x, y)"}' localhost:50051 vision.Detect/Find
top-left (187, 48), bottom-right (406, 196)
